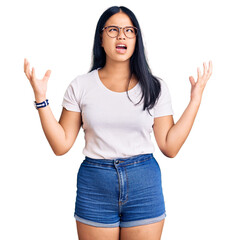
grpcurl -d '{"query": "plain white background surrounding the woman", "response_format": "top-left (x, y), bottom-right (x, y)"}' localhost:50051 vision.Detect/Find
top-left (0, 0), bottom-right (236, 240)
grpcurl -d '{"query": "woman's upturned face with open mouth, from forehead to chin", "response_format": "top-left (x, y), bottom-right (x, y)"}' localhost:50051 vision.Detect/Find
top-left (102, 12), bottom-right (136, 61)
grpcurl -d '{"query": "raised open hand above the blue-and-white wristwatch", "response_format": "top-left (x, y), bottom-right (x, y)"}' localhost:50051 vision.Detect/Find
top-left (24, 58), bottom-right (51, 102)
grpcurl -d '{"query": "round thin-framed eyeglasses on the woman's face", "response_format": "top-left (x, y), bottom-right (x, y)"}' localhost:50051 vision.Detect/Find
top-left (102, 26), bottom-right (138, 38)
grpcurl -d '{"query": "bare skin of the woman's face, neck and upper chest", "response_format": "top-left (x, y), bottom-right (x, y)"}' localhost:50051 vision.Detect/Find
top-left (98, 12), bottom-right (138, 92)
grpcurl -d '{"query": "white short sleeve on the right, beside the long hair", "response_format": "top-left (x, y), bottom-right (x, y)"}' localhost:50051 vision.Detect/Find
top-left (154, 79), bottom-right (174, 118)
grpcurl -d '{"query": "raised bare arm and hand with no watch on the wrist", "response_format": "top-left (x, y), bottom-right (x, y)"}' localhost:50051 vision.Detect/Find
top-left (153, 61), bottom-right (212, 158)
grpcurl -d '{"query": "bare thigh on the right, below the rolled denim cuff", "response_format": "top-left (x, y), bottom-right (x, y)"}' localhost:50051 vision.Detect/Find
top-left (120, 219), bottom-right (165, 240)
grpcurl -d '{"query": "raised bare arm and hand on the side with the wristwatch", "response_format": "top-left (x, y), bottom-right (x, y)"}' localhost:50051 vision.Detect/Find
top-left (24, 59), bottom-right (82, 156)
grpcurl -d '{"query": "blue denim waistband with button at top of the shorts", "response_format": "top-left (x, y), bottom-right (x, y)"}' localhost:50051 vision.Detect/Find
top-left (83, 153), bottom-right (153, 166)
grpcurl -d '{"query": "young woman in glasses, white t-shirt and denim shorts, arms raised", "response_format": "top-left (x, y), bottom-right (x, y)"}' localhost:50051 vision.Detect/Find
top-left (24, 6), bottom-right (212, 240)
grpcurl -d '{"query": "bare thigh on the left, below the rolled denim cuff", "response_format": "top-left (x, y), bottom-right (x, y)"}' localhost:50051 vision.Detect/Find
top-left (76, 221), bottom-right (120, 240)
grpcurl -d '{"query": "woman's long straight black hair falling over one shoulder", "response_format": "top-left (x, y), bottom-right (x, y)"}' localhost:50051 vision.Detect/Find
top-left (89, 6), bottom-right (162, 114)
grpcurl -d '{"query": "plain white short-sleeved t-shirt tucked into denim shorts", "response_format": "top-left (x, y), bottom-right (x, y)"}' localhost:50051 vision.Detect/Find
top-left (62, 68), bottom-right (173, 159)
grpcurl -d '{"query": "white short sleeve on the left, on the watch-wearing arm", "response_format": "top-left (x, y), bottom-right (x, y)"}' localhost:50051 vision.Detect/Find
top-left (62, 79), bottom-right (81, 112)
